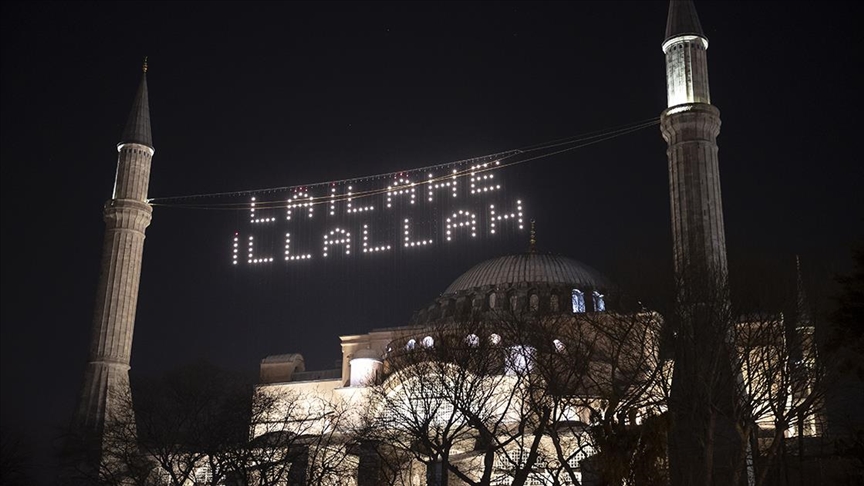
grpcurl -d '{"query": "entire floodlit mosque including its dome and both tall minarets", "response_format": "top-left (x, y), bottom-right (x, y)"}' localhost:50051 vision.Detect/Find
top-left (71, 0), bottom-right (818, 485)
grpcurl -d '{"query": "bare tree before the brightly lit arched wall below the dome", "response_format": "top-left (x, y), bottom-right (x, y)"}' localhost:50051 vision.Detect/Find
top-left (367, 321), bottom-right (530, 484)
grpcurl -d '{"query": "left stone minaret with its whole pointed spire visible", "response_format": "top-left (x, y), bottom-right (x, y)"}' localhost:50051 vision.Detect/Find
top-left (76, 59), bottom-right (154, 434)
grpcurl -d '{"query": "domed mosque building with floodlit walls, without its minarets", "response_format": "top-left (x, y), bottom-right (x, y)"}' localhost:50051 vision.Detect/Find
top-left (253, 249), bottom-right (668, 485)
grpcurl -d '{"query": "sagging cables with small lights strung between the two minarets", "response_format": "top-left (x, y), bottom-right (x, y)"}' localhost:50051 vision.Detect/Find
top-left (148, 117), bottom-right (659, 211)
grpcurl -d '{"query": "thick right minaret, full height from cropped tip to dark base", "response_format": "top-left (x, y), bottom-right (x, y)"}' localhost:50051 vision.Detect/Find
top-left (660, 0), bottom-right (745, 486)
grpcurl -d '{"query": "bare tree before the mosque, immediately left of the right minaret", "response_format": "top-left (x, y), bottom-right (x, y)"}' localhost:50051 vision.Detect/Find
top-left (500, 306), bottom-right (671, 484)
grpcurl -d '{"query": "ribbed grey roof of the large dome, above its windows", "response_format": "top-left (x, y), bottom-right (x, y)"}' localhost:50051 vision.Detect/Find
top-left (444, 253), bottom-right (610, 294)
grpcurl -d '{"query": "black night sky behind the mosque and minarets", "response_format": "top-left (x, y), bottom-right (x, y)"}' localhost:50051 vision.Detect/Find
top-left (0, 1), bottom-right (864, 478)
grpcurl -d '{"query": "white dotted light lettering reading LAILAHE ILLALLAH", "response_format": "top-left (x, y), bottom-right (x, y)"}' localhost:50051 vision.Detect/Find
top-left (231, 159), bottom-right (526, 265)
